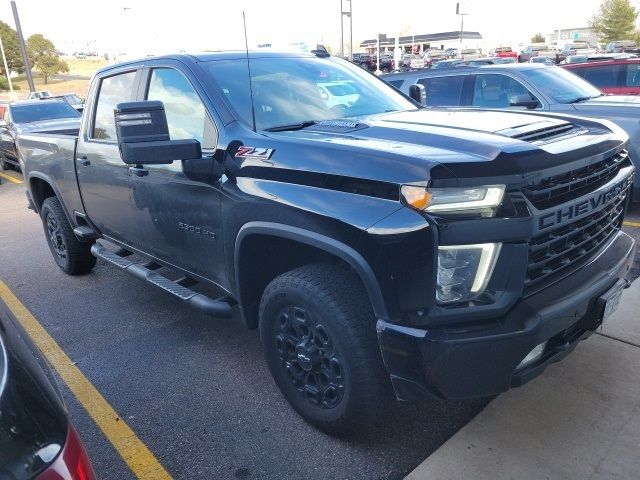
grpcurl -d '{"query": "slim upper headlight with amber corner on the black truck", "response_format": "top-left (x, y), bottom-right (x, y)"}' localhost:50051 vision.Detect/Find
top-left (400, 185), bottom-right (505, 217)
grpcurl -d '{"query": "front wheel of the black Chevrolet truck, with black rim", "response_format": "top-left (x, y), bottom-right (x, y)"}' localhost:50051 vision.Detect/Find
top-left (260, 264), bottom-right (390, 435)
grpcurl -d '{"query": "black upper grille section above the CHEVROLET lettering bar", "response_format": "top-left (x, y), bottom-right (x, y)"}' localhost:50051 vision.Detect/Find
top-left (522, 150), bottom-right (629, 210)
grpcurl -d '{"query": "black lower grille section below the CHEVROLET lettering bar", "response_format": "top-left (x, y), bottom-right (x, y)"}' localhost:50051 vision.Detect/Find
top-left (525, 182), bottom-right (631, 291)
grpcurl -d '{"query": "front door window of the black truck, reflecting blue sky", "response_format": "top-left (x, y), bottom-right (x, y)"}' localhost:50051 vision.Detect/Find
top-left (147, 68), bottom-right (217, 149)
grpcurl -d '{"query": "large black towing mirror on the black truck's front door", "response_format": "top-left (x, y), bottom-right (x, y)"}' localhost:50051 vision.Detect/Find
top-left (114, 101), bottom-right (202, 165)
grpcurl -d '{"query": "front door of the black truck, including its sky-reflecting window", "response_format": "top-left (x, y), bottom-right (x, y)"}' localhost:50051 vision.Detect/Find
top-left (131, 67), bottom-right (227, 287)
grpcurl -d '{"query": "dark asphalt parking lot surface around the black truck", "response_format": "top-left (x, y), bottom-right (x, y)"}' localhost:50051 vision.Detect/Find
top-left (0, 172), bottom-right (640, 479)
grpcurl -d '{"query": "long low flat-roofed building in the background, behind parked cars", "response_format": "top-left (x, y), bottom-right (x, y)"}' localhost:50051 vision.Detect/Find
top-left (360, 31), bottom-right (482, 53)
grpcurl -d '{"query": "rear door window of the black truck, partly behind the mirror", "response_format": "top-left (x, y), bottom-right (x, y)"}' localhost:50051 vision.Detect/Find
top-left (91, 71), bottom-right (136, 142)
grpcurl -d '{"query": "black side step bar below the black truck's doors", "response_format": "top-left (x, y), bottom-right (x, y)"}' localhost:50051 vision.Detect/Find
top-left (91, 243), bottom-right (232, 318)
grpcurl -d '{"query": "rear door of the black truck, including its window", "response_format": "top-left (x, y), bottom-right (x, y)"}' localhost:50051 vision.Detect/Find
top-left (76, 70), bottom-right (139, 245)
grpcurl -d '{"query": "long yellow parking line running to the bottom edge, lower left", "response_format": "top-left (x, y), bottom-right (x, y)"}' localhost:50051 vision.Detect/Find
top-left (0, 280), bottom-right (171, 480)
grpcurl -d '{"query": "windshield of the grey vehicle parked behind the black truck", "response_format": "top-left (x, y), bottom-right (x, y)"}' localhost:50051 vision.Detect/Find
top-left (527, 67), bottom-right (602, 103)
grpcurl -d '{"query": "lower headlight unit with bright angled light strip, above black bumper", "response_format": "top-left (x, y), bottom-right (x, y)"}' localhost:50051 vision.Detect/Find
top-left (436, 243), bottom-right (502, 303)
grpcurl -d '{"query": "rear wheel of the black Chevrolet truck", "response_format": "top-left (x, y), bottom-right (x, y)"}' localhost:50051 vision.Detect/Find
top-left (40, 197), bottom-right (96, 275)
